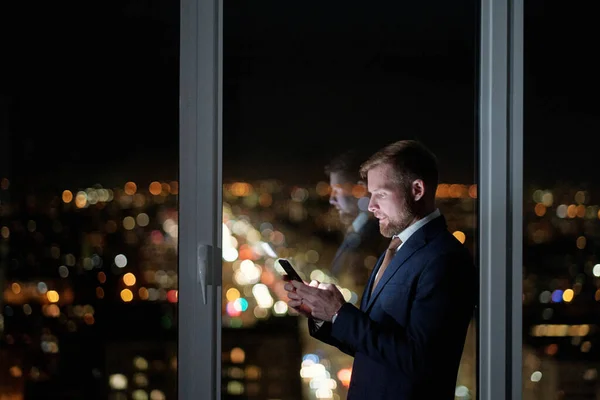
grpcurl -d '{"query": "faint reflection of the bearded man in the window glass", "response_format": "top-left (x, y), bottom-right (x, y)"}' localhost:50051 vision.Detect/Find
top-left (325, 150), bottom-right (387, 287)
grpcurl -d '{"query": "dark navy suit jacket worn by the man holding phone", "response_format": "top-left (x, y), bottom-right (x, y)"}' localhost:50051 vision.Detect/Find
top-left (309, 216), bottom-right (477, 400)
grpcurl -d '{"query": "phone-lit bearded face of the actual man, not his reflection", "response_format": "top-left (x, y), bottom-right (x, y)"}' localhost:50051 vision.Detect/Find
top-left (367, 164), bottom-right (416, 237)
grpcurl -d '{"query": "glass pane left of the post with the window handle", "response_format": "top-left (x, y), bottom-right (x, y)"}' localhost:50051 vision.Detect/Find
top-left (0, 1), bottom-right (179, 399)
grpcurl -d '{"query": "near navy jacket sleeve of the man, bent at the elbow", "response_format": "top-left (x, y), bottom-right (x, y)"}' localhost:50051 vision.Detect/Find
top-left (330, 252), bottom-right (476, 380)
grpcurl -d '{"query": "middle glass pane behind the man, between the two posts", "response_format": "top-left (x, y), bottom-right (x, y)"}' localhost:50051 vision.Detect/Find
top-left (222, 0), bottom-right (479, 399)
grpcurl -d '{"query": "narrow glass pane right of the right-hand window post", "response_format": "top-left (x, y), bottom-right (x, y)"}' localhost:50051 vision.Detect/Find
top-left (523, 2), bottom-right (600, 400)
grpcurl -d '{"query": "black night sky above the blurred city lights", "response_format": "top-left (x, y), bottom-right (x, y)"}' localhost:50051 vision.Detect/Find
top-left (0, 1), bottom-right (600, 191)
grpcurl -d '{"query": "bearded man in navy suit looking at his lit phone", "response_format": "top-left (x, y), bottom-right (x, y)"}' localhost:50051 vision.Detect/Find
top-left (285, 141), bottom-right (477, 400)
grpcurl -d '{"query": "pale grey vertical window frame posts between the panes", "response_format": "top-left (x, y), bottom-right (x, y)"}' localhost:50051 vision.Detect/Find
top-left (178, 0), bottom-right (523, 400)
